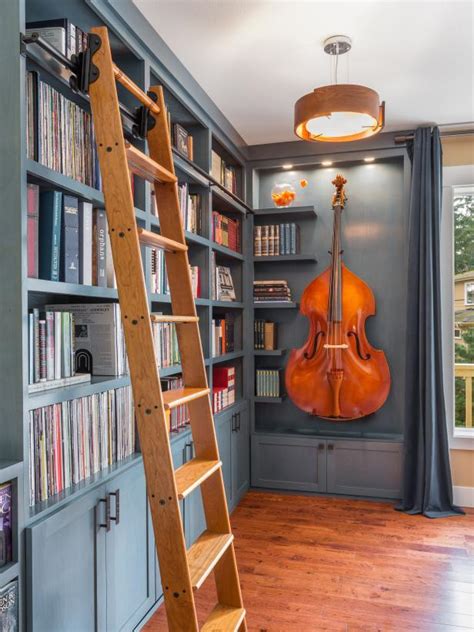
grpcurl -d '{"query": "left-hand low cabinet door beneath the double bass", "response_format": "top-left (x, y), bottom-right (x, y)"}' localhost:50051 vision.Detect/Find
top-left (252, 434), bottom-right (326, 492)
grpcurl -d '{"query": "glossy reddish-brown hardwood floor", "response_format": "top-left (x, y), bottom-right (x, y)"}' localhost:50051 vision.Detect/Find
top-left (144, 492), bottom-right (474, 632)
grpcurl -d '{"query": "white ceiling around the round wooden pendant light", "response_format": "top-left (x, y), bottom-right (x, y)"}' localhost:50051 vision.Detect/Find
top-left (134, 0), bottom-right (474, 145)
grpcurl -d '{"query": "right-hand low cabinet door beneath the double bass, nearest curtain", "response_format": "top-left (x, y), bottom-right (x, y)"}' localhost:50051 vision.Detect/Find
top-left (327, 439), bottom-right (402, 498)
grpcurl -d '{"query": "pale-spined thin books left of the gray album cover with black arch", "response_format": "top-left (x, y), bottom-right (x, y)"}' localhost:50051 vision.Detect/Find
top-left (28, 307), bottom-right (91, 393)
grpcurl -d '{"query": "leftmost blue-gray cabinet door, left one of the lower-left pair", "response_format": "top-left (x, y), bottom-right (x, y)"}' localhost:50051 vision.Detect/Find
top-left (25, 487), bottom-right (106, 632)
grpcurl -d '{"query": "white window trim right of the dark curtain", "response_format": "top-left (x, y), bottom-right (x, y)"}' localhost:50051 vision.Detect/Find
top-left (441, 165), bottom-right (474, 450)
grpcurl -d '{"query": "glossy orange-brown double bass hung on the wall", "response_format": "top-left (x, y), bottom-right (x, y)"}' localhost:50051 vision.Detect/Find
top-left (285, 175), bottom-right (390, 421)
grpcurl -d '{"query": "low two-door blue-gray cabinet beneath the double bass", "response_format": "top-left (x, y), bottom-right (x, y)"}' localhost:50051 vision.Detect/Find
top-left (251, 433), bottom-right (402, 498)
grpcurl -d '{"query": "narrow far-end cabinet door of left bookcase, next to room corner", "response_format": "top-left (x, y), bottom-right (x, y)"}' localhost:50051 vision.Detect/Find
top-left (231, 408), bottom-right (250, 506)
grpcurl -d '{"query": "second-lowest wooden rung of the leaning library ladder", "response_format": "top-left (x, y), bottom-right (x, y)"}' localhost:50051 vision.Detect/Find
top-left (188, 531), bottom-right (234, 590)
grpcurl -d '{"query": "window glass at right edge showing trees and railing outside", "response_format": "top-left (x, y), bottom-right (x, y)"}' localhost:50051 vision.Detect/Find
top-left (453, 187), bottom-right (474, 436)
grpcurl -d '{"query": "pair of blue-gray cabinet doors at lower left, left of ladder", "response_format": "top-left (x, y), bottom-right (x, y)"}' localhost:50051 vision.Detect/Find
top-left (25, 461), bottom-right (156, 632)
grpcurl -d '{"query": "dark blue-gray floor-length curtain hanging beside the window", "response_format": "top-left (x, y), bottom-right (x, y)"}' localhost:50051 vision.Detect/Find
top-left (397, 127), bottom-right (463, 518)
